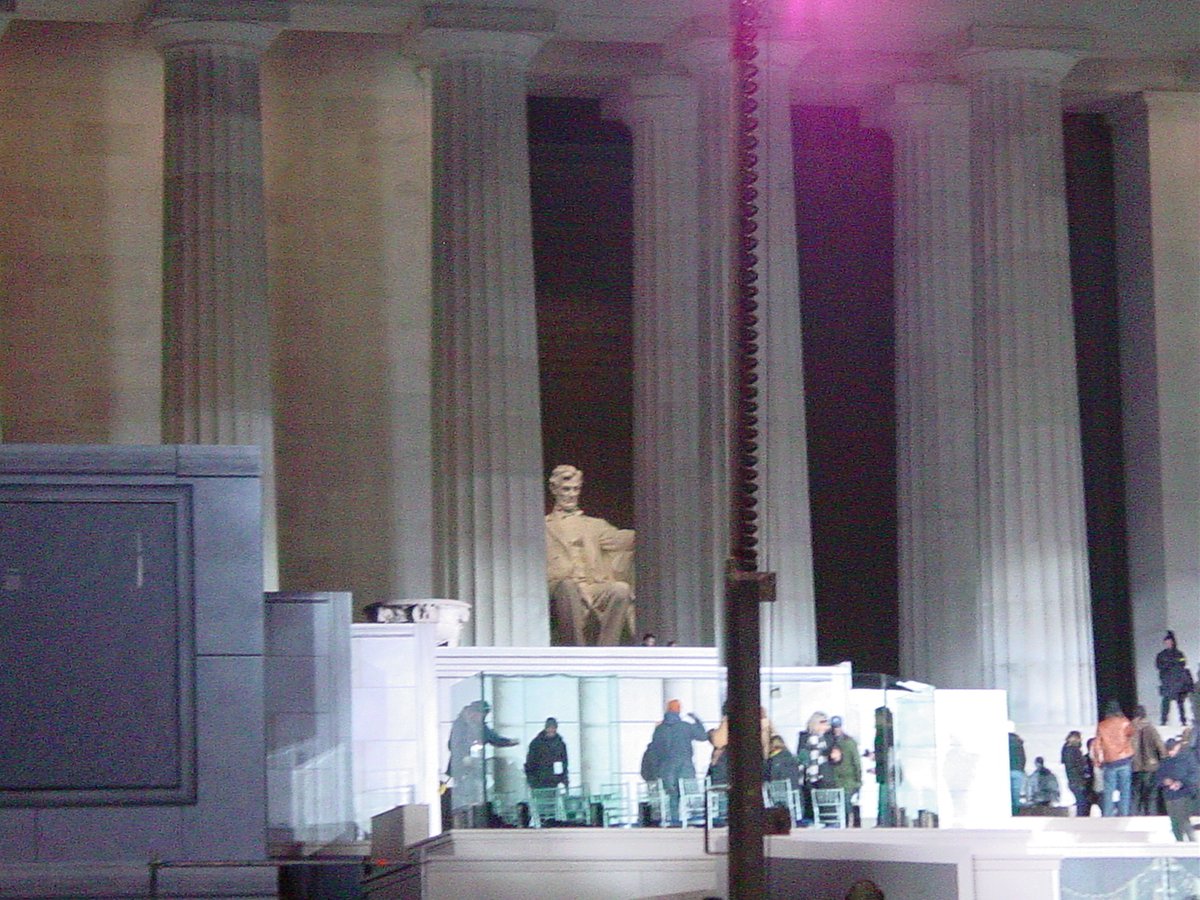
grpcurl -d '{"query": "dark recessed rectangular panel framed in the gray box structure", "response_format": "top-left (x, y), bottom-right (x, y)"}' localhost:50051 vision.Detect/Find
top-left (0, 484), bottom-right (196, 805)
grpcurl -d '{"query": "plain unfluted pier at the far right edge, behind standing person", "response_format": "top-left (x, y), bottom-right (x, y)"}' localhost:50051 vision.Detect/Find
top-left (1108, 91), bottom-right (1200, 715)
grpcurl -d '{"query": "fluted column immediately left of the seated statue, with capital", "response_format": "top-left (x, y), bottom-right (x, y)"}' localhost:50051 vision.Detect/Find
top-left (413, 8), bottom-right (552, 647)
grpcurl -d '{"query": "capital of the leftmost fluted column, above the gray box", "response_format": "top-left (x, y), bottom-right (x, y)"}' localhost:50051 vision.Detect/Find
top-left (142, 0), bottom-right (290, 56)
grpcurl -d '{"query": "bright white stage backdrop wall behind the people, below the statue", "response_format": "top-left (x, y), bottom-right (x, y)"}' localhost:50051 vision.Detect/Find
top-left (352, 624), bottom-right (1012, 836)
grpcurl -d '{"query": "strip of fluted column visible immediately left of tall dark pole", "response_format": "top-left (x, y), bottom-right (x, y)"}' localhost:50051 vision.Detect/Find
top-left (676, 19), bottom-right (737, 647)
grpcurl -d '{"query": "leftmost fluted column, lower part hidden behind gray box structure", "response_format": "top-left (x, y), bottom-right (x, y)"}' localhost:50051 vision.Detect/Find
top-left (144, 0), bottom-right (288, 590)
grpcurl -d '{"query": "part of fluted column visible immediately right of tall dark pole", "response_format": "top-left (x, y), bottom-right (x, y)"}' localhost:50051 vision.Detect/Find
top-left (757, 32), bottom-right (817, 666)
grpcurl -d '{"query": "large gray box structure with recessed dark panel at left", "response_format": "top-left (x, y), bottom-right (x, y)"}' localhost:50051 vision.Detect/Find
top-left (0, 444), bottom-right (266, 873)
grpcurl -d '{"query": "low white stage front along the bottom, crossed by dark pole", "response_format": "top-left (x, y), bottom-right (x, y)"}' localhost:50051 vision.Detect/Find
top-left (366, 817), bottom-right (1200, 900)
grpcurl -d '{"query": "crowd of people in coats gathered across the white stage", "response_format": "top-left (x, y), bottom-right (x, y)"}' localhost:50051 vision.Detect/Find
top-left (446, 631), bottom-right (1200, 841)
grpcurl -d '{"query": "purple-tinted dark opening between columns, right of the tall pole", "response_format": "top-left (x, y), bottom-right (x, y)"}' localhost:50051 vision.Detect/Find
top-left (793, 107), bottom-right (900, 673)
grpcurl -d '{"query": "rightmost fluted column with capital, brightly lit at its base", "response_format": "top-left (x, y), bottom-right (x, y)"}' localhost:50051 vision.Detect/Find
top-left (961, 49), bottom-right (1096, 725)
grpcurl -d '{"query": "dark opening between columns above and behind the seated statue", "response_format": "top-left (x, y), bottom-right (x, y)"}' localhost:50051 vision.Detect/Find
top-left (529, 97), bottom-right (635, 528)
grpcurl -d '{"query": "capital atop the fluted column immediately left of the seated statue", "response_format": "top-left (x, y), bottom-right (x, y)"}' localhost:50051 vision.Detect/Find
top-left (406, 6), bottom-right (556, 68)
